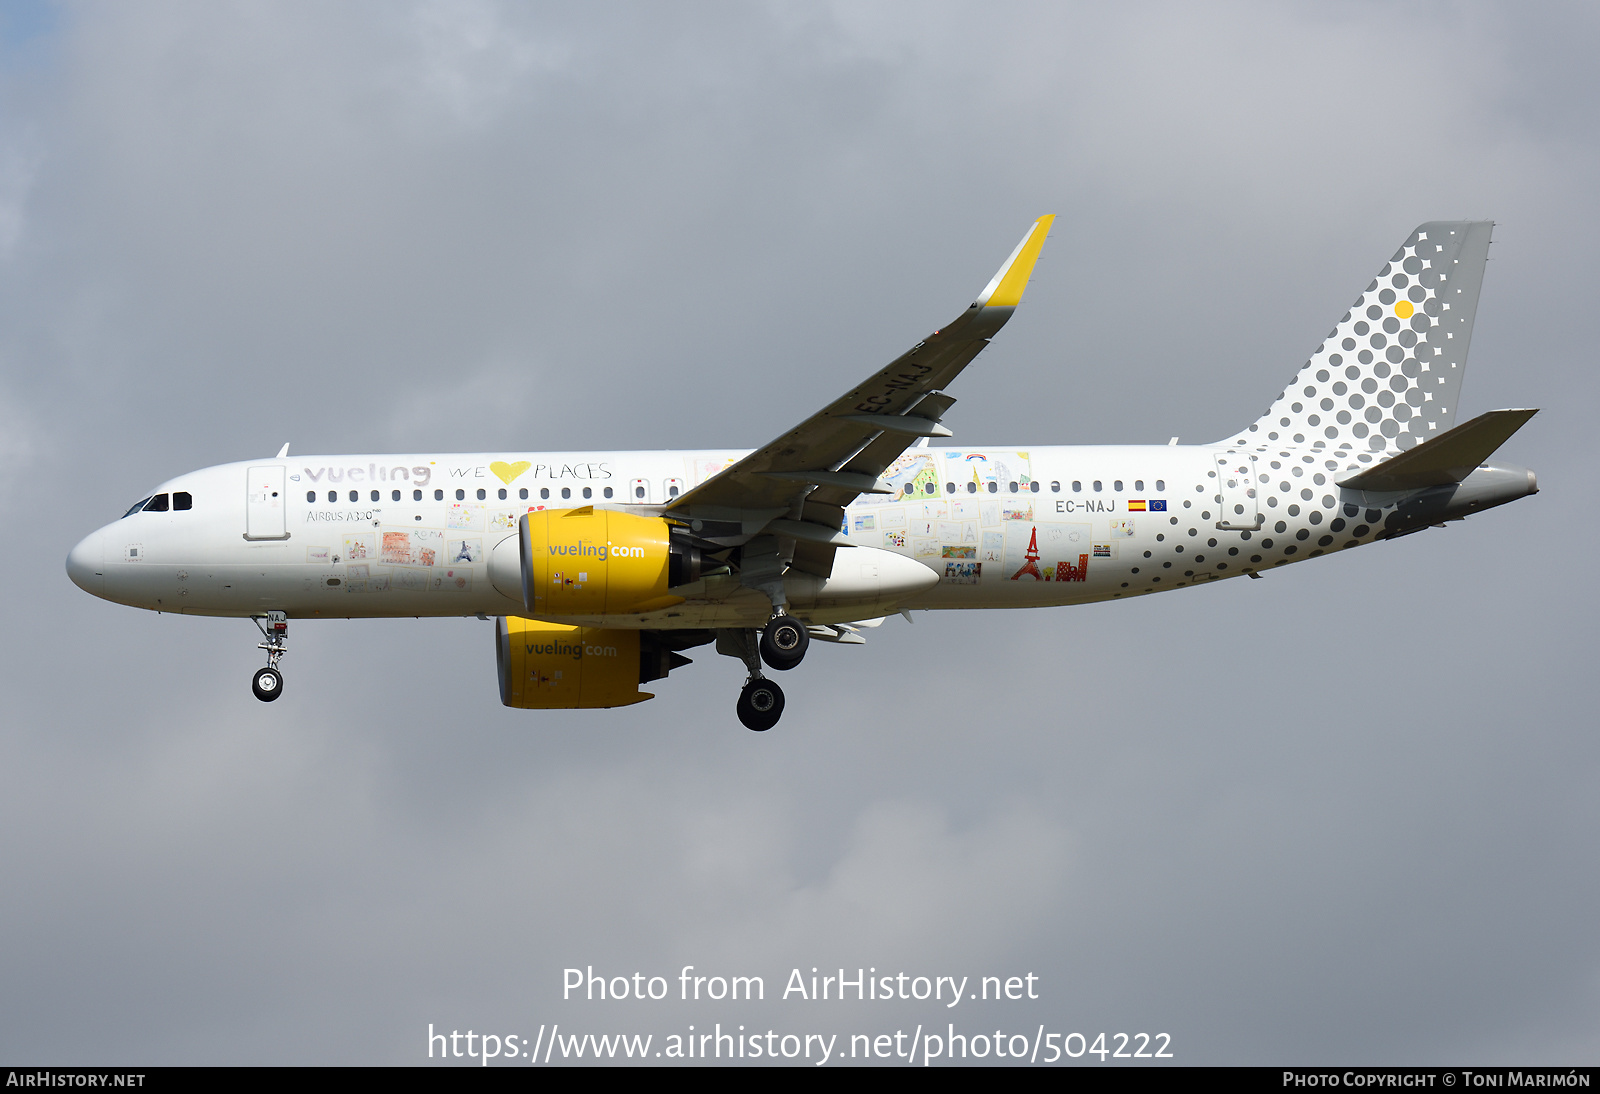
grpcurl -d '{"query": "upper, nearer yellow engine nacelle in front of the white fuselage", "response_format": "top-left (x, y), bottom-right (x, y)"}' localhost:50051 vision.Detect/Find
top-left (520, 507), bottom-right (683, 616)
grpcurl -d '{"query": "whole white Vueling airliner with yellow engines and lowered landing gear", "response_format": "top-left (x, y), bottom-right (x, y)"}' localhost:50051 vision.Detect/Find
top-left (67, 216), bottom-right (1538, 729)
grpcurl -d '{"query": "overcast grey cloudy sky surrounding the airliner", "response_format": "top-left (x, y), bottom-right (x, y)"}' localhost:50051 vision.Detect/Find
top-left (0, 0), bottom-right (1600, 1065)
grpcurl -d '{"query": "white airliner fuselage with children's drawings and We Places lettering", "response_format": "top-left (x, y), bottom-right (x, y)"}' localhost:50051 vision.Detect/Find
top-left (67, 445), bottom-right (1536, 629)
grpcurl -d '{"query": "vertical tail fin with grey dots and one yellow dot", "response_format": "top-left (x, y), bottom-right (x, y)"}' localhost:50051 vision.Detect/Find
top-left (1221, 221), bottom-right (1494, 459)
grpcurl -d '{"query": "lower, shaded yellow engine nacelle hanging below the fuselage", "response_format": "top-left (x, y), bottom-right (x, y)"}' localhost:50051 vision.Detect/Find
top-left (494, 616), bottom-right (652, 710)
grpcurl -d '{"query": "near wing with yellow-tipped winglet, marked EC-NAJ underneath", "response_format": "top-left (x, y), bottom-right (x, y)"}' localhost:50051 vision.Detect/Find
top-left (664, 216), bottom-right (1056, 574)
